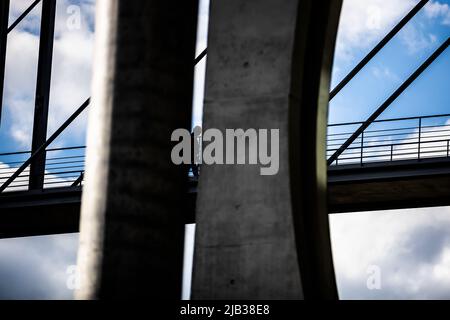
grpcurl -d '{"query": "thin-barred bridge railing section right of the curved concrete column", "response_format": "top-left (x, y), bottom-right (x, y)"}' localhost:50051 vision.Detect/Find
top-left (327, 114), bottom-right (450, 166)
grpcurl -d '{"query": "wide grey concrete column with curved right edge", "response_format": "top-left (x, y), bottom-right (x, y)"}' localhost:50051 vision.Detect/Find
top-left (193, 0), bottom-right (341, 299)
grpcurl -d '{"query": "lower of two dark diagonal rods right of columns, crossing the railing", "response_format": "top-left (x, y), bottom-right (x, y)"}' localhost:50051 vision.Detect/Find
top-left (327, 38), bottom-right (450, 165)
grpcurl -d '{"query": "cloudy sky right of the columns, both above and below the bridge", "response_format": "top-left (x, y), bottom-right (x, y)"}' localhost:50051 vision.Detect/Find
top-left (329, 0), bottom-right (450, 299)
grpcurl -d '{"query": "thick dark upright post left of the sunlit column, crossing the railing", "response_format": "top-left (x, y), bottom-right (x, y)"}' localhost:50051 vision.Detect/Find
top-left (29, 0), bottom-right (56, 190)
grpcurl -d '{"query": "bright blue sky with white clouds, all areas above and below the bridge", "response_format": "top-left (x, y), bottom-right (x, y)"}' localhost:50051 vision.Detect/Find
top-left (0, 0), bottom-right (450, 299)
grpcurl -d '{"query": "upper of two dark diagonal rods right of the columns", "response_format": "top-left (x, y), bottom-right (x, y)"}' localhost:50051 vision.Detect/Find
top-left (330, 0), bottom-right (429, 101)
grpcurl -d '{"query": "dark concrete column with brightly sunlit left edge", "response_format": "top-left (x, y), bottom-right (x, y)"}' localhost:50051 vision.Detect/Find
top-left (76, 0), bottom-right (198, 299)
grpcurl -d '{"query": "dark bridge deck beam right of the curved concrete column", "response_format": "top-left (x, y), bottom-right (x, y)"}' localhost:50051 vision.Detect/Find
top-left (328, 158), bottom-right (450, 213)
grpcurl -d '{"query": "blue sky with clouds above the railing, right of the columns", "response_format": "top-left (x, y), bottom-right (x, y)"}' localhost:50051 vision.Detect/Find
top-left (329, 0), bottom-right (450, 123)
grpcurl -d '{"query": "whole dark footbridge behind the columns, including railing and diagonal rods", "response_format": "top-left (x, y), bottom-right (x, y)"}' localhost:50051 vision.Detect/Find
top-left (0, 0), bottom-right (450, 241)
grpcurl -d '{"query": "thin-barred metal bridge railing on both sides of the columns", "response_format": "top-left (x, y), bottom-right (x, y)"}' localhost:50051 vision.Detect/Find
top-left (0, 114), bottom-right (450, 192)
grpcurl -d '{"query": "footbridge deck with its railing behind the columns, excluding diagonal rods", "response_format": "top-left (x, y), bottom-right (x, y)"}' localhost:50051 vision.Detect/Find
top-left (0, 114), bottom-right (450, 237)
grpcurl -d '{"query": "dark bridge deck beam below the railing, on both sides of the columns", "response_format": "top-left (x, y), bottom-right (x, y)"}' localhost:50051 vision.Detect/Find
top-left (0, 159), bottom-right (450, 239)
